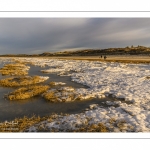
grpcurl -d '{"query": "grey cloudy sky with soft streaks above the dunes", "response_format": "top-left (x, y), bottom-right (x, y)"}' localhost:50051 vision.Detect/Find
top-left (0, 18), bottom-right (150, 55)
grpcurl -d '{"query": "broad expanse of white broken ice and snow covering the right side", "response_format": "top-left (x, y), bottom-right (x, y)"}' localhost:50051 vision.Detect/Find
top-left (1, 58), bottom-right (150, 132)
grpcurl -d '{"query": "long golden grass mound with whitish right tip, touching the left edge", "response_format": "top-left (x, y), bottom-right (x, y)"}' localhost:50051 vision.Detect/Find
top-left (0, 76), bottom-right (47, 87)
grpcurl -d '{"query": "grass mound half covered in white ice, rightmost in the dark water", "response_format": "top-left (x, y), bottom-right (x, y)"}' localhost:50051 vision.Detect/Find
top-left (43, 87), bottom-right (79, 102)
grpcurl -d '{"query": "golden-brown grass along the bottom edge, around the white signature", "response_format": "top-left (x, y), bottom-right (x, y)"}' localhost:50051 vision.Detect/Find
top-left (0, 114), bottom-right (109, 132)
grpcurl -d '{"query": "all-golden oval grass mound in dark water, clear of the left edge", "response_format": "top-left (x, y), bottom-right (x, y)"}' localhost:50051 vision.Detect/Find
top-left (7, 85), bottom-right (49, 100)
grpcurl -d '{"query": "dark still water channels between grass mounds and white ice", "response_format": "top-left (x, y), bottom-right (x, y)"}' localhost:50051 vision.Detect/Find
top-left (0, 64), bottom-right (126, 121)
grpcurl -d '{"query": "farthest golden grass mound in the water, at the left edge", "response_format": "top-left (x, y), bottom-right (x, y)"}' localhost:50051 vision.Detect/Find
top-left (0, 63), bottom-right (29, 75)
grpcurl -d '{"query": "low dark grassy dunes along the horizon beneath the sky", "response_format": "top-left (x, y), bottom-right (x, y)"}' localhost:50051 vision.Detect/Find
top-left (0, 45), bottom-right (150, 57)
